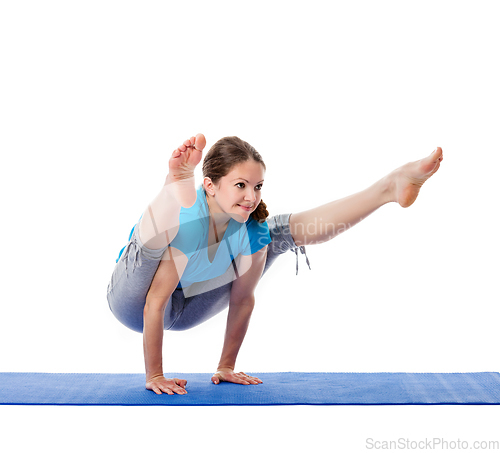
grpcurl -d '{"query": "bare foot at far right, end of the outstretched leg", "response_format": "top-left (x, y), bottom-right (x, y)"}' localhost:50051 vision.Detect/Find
top-left (392, 147), bottom-right (443, 208)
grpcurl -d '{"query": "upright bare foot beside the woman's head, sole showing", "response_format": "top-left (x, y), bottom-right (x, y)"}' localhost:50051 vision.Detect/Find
top-left (165, 134), bottom-right (206, 208)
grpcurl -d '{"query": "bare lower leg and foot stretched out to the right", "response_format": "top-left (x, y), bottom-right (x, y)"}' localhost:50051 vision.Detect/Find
top-left (290, 147), bottom-right (443, 246)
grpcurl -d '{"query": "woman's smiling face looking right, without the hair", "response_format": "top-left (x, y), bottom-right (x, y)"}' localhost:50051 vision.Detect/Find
top-left (204, 159), bottom-right (265, 223)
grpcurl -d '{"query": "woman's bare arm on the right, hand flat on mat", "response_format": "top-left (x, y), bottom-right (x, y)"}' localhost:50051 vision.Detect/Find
top-left (212, 246), bottom-right (267, 384)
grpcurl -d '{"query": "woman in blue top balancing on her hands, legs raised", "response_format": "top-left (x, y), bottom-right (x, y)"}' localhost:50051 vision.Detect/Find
top-left (107, 134), bottom-right (443, 395)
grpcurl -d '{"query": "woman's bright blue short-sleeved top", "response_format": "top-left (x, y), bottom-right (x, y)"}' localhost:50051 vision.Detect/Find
top-left (116, 185), bottom-right (271, 288)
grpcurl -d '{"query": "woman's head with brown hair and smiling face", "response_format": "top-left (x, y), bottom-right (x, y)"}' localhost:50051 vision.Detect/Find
top-left (202, 137), bottom-right (269, 222)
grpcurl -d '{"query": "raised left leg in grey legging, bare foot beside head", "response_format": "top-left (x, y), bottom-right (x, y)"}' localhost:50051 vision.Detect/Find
top-left (107, 134), bottom-right (206, 332)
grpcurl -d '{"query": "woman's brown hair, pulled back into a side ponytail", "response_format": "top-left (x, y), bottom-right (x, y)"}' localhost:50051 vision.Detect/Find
top-left (202, 136), bottom-right (269, 223)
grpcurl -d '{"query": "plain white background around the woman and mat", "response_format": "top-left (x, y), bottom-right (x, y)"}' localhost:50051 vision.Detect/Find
top-left (0, 0), bottom-right (500, 451)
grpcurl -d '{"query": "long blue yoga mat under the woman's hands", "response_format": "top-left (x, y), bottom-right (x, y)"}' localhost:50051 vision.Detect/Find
top-left (0, 372), bottom-right (500, 406)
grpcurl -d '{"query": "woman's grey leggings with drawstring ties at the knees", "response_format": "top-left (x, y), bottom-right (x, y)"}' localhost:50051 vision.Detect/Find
top-left (108, 214), bottom-right (311, 332)
